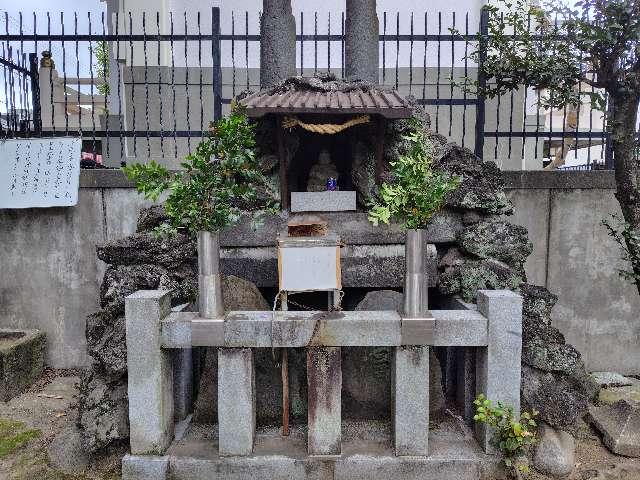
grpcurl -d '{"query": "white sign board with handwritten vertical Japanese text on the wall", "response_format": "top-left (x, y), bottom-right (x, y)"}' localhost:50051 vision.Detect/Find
top-left (0, 138), bottom-right (82, 208)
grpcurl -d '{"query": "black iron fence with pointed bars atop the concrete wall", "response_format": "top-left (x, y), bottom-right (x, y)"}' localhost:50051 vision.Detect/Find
top-left (0, 8), bottom-right (632, 169)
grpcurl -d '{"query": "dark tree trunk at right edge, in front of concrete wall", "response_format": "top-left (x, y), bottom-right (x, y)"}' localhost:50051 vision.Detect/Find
top-left (610, 92), bottom-right (640, 293)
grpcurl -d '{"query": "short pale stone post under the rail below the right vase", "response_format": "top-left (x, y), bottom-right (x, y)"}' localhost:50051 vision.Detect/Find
top-left (392, 346), bottom-right (429, 456)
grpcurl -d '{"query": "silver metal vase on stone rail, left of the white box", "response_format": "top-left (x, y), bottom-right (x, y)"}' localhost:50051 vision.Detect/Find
top-left (198, 231), bottom-right (224, 318)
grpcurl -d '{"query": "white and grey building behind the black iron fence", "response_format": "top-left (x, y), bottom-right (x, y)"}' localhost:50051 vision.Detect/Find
top-left (32, 0), bottom-right (603, 170)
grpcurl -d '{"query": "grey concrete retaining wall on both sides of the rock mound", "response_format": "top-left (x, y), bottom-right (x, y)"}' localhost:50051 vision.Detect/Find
top-left (0, 171), bottom-right (640, 373)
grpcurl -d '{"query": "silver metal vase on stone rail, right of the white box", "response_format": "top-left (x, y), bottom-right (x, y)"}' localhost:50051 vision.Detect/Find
top-left (404, 229), bottom-right (429, 318)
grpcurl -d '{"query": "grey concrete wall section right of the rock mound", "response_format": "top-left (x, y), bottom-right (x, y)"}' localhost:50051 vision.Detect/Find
top-left (507, 172), bottom-right (640, 373)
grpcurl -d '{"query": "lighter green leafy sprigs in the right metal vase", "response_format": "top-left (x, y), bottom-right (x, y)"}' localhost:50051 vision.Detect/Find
top-left (369, 122), bottom-right (461, 229)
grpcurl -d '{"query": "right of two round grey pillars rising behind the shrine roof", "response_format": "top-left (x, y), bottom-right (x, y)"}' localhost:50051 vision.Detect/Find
top-left (344, 0), bottom-right (379, 84)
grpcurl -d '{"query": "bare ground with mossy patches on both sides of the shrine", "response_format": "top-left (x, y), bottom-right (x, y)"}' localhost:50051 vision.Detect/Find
top-left (0, 370), bottom-right (640, 480)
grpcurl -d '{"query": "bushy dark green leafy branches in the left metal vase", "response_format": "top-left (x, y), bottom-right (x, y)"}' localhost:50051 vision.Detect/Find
top-left (123, 112), bottom-right (275, 234)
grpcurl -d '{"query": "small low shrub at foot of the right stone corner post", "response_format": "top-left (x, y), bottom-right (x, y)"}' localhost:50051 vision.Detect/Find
top-left (473, 394), bottom-right (538, 473)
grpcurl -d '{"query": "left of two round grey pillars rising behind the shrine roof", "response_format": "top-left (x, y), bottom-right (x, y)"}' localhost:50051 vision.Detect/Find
top-left (260, 0), bottom-right (296, 88)
